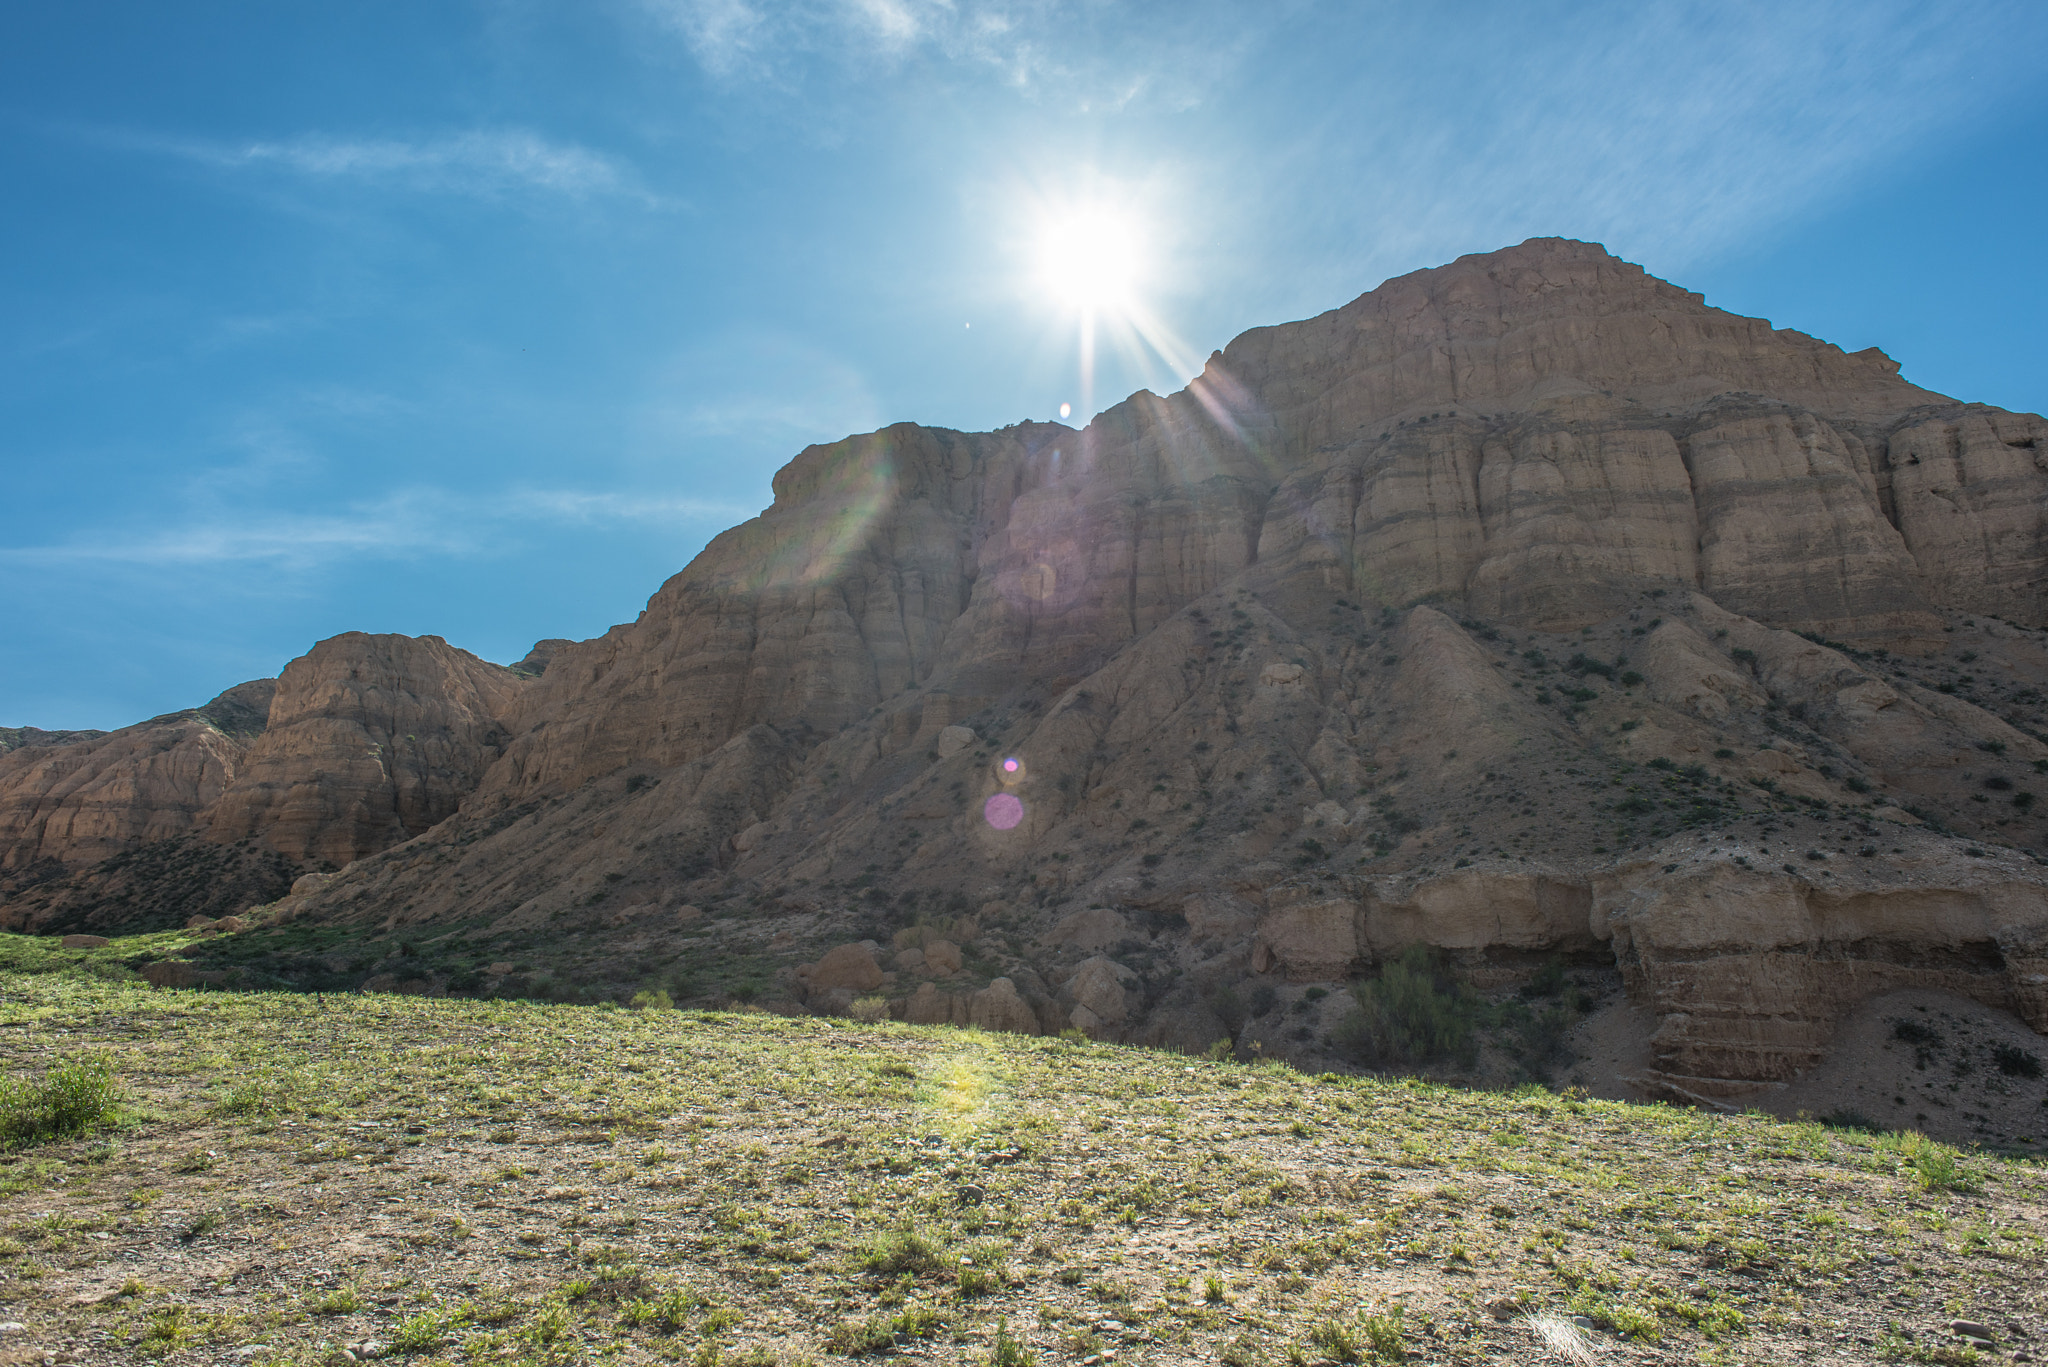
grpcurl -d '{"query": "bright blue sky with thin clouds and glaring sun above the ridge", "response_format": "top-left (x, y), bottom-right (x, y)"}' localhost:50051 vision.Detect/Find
top-left (0, 0), bottom-right (2048, 730)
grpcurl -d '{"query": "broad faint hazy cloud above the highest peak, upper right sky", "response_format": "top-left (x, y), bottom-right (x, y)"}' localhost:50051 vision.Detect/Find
top-left (1236, 0), bottom-right (2048, 288)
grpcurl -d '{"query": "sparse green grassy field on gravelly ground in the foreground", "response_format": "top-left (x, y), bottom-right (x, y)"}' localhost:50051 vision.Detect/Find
top-left (0, 945), bottom-right (2048, 1367)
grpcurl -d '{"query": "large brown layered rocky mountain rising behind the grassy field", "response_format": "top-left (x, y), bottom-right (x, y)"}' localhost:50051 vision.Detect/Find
top-left (0, 240), bottom-right (2048, 1139)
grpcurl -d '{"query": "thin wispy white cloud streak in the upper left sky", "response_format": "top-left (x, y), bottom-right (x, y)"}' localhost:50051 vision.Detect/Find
top-left (109, 129), bottom-right (651, 199)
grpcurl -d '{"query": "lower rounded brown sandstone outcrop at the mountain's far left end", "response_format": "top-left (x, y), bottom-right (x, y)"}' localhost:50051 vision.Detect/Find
top-left (0, 631), bottom-right (549, 930)
